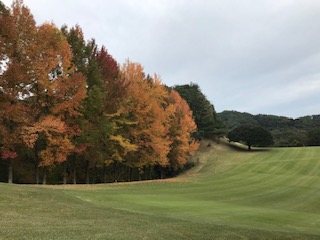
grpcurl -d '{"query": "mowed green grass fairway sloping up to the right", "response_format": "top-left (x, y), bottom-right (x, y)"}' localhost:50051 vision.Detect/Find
top-left (0, 144), bottom-right (320, 239)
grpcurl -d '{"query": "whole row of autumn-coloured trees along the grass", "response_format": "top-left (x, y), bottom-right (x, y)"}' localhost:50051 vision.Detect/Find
top-left (0, 0), bottom-right (198, 183)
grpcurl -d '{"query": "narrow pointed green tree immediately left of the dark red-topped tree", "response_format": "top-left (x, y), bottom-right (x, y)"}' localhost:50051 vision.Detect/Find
top-left (81, 40), bottom-right (108, 183)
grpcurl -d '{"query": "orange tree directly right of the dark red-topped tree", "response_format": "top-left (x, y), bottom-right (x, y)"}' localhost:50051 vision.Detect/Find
top-left (122, 61), bottom-right (174, 180)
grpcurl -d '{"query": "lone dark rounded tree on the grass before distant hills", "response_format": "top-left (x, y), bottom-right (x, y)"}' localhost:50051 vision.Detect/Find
top-left (228, 125), bottom-right (273, 150)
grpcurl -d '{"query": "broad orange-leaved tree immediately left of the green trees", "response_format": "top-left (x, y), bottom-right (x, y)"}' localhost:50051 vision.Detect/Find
top-left (28, 24), bottom-right (86, 183)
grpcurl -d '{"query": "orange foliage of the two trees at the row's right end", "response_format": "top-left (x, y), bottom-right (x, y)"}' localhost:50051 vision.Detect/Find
top-left (121, 61), bottom-right (198, 169)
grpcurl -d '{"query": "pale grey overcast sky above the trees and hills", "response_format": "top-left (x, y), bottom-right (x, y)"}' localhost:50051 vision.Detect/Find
top-left (3, 0), bottom-right (320, 118)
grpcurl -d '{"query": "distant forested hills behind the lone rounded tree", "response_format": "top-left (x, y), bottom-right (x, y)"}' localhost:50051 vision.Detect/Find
top-left (217, 111), bottom-right (320, 147)
